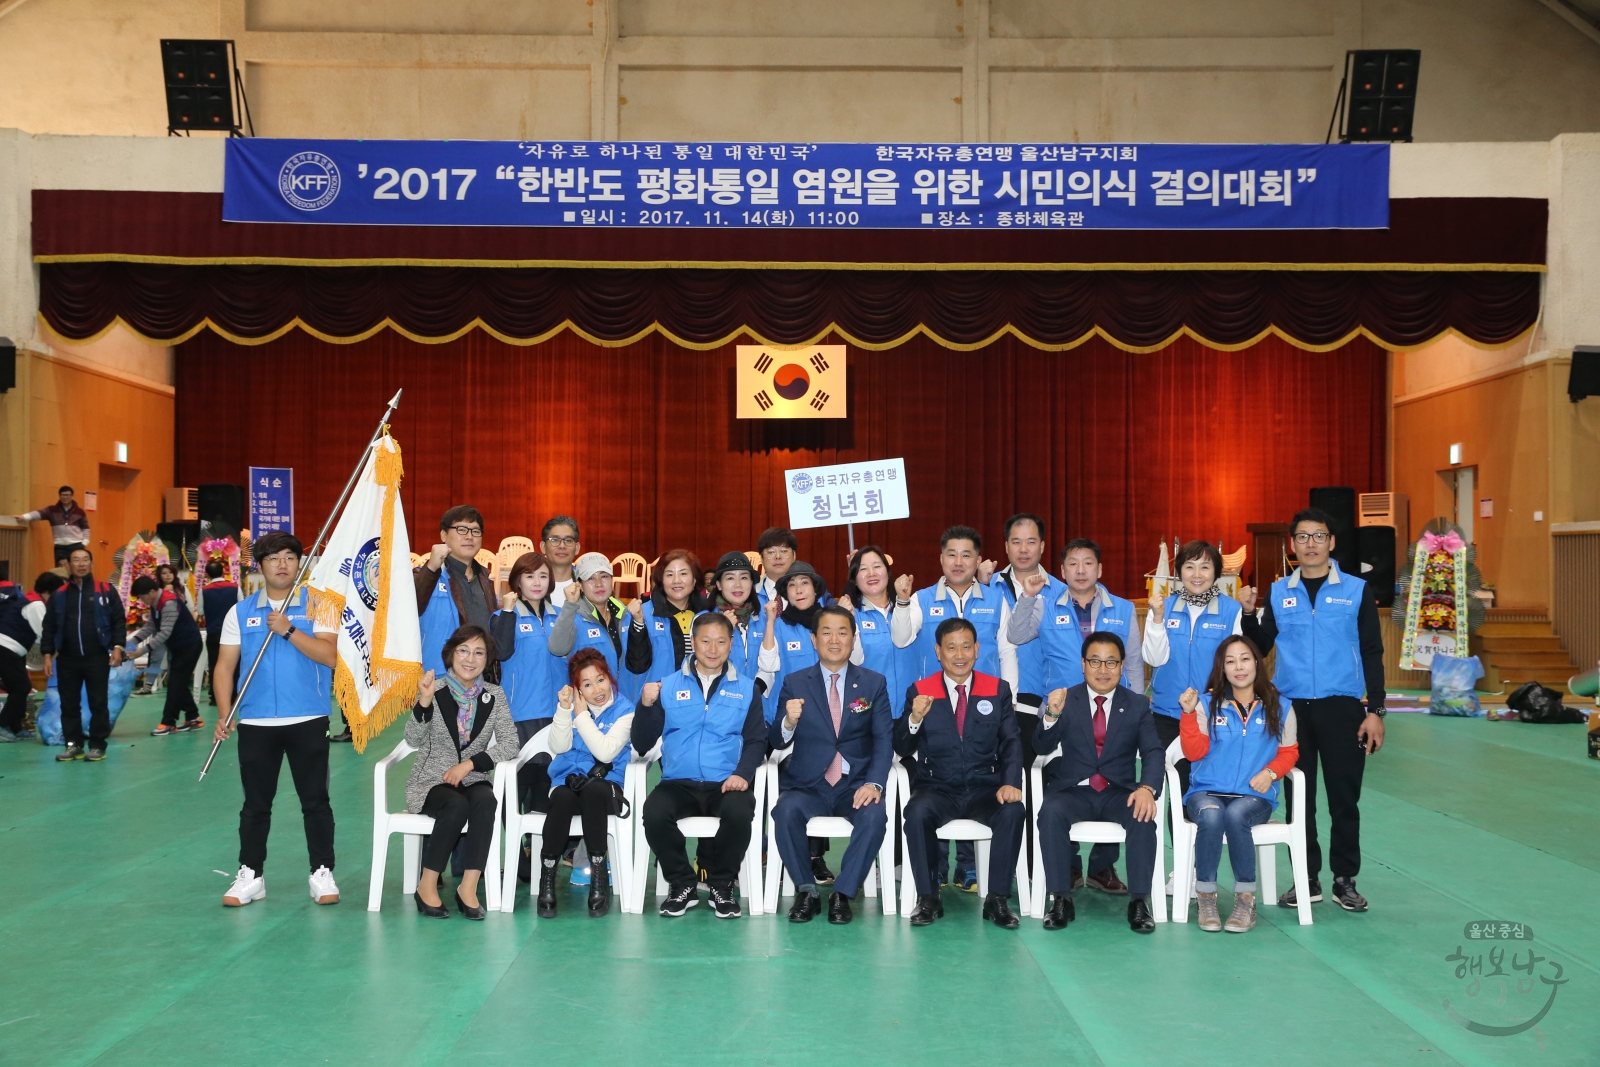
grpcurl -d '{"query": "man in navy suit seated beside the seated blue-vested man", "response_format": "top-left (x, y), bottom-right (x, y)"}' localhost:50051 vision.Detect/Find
top-left (768, 606), bottom-right (894, 925)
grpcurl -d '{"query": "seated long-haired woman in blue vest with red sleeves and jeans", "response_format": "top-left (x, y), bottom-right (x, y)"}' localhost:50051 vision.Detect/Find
top-left (1178, 635), bottom-right (1299, 934)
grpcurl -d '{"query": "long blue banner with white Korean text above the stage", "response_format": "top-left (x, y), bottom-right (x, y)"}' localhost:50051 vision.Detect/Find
top-left (222, 138), bottom-right (1389, 230)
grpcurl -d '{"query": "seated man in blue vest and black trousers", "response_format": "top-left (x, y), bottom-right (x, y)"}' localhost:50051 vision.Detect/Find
top-left (634, 611), bottom-right (766, 918)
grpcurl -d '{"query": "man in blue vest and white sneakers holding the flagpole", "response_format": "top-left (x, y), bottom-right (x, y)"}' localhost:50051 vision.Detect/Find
top-left (213, 531), bottom-right (339, 907)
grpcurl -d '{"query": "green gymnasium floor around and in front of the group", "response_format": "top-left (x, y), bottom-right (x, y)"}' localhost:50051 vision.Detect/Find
top-left (0, 697), bottom-right (1600, 1067)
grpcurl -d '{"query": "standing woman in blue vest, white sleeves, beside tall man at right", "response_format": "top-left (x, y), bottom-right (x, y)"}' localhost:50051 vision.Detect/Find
top-left (1141, 541), bottom-right (1242, 777)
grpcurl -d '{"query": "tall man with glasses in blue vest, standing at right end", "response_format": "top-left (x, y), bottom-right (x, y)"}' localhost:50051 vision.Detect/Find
top-left (1238, 507), bottom-right (1386, 912)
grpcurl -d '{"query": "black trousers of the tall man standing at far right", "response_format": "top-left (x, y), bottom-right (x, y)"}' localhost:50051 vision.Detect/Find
top-left (1283, 696), bottom-right (1366, 878)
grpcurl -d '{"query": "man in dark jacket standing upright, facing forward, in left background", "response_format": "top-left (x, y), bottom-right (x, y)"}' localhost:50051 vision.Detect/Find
top-left (38, 545), bottom-right (128, 763)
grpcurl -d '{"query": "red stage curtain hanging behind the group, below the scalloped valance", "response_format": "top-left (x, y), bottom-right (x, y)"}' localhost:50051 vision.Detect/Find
top-left (178, 331), bottom-right (1387, 595)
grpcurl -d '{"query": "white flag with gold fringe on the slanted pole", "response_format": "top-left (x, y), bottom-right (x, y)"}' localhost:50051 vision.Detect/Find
top-left (307, 434), bottom-right (422, 752)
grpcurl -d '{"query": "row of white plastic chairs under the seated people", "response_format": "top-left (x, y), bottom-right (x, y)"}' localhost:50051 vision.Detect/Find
top-left (366, 728), bottom-right (1312, 926)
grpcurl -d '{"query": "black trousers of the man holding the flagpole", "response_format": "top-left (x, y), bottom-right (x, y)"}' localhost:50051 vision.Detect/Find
top-left (238, 715), bottom-right (333, 875)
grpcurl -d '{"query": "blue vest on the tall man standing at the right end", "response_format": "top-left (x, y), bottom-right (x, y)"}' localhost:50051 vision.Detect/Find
top-left (1272, 561), bottom-right (1366, 701)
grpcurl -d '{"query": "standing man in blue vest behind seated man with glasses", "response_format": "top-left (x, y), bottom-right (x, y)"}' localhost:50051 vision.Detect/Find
top-left (1010, 537), bottom-right (1144, 894)
